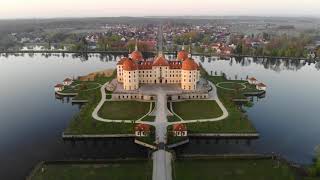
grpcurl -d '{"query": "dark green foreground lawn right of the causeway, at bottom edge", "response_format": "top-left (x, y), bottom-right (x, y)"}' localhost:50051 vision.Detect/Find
top-left (174, 159), bottom-right (296, 180)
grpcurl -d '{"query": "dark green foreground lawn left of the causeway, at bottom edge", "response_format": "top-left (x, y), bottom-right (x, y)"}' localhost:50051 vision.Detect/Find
top-left (31, 161), bottom-right (152, 180)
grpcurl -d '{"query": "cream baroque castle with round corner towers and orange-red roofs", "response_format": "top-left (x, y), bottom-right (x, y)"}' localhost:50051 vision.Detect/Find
top-left (117, 44), bottom-right (200, 91)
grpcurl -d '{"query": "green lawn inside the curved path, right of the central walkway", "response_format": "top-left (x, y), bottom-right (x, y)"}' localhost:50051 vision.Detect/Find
top-left (172, 100), bottom-right (222, 120)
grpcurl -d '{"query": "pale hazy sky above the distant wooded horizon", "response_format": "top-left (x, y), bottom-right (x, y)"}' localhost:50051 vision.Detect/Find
top-left (0, 0), bottom-right (320, 19)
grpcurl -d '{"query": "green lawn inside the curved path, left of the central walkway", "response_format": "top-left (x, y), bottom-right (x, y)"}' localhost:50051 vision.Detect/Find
top-left (98, 101), bottom-right (150, 120)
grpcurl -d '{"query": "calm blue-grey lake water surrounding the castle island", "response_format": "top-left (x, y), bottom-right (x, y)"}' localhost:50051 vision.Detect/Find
top-left (0, 54), bottom-right (320, 180)
